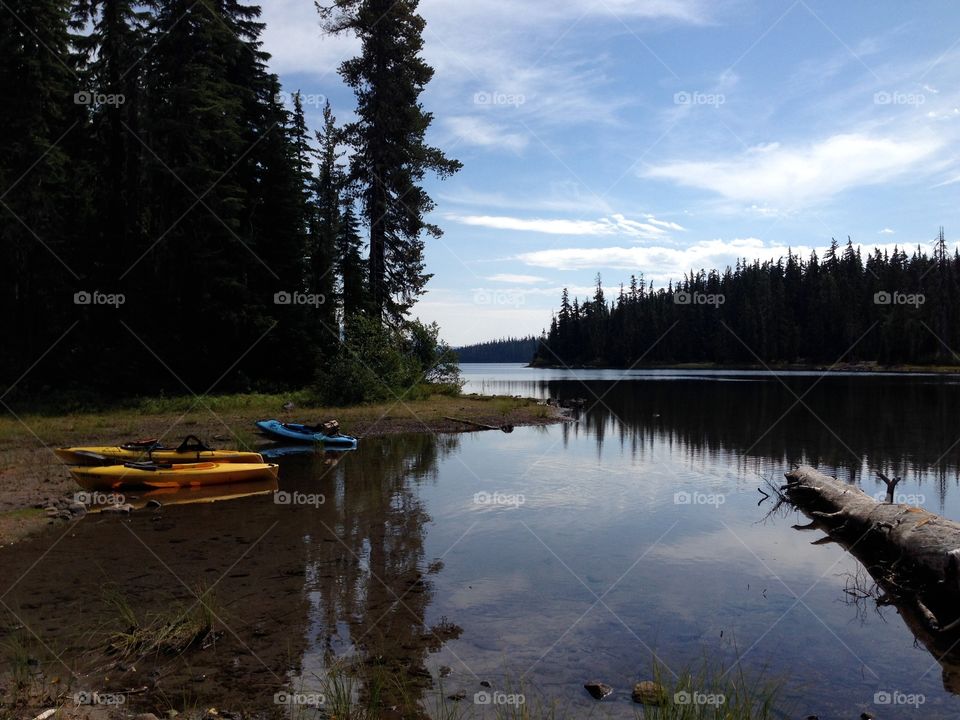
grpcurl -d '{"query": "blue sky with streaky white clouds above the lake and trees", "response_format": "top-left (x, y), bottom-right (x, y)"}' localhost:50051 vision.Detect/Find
top-left (263, 0), bottom-right (960, 344)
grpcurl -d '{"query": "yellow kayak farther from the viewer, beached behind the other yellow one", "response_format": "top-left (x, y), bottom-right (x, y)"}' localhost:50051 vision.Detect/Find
top-left (54, 435), bottom-right (263, 465)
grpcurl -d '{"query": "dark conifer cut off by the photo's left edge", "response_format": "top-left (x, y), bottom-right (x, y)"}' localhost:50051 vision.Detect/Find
top-left (0, 0), bottom-right (84, 389)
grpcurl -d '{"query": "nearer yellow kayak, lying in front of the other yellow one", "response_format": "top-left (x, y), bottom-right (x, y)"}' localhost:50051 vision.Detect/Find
top-left (70, 462), bottom-right (279, 490)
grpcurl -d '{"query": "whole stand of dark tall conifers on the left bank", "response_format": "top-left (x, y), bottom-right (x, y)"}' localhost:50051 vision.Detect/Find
top-left (0, 0), bottom-right (460, 401)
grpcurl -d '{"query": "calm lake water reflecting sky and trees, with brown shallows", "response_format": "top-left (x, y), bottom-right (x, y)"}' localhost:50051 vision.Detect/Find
top-left (0, 365), bottom-right (960, 719)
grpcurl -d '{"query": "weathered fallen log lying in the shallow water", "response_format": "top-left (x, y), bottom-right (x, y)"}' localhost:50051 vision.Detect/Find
top-left (781, 467), bottom-right (960, 693)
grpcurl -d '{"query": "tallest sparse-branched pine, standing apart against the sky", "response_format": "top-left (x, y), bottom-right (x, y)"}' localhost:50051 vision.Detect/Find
top-left (317, 0), bottom-right (461, 322)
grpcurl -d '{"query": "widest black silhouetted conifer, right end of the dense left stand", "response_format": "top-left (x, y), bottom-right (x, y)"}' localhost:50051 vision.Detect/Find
top-left (135, 0), bottom-right (300, 387)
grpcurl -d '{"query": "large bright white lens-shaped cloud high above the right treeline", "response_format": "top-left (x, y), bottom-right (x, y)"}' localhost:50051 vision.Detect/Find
top-left (644, 133), bottom-right (943, 207)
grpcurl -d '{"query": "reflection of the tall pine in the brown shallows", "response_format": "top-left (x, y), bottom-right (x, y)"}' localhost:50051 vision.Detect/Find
top-left (298, 433), bottom-right (461, 714)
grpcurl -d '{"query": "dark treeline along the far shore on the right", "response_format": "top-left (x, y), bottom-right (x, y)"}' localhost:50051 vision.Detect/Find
top-left (536, 230), bottom-right (960, 367)
